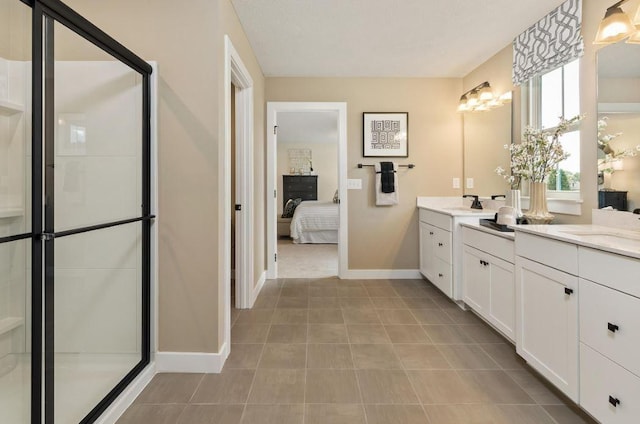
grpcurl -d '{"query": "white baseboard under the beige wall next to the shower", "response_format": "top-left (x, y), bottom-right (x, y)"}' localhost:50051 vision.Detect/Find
top-left (156, 343), bottom-right (229, 374)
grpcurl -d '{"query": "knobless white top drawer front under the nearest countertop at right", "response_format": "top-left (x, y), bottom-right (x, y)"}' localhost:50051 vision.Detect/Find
top-left (578, 247), bottom-right (640, 297)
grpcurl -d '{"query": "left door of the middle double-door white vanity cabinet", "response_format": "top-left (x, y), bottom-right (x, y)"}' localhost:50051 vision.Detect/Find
top-left (462, 245), bottom-right (491, 319)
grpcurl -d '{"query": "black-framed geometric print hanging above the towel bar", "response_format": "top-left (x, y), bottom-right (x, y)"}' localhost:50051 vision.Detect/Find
top-left (362, 112), bottom-right (409, 158)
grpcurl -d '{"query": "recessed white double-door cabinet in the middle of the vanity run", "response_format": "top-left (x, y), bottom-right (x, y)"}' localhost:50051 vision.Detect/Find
top-left (462, 226), bottom-right (516, 342)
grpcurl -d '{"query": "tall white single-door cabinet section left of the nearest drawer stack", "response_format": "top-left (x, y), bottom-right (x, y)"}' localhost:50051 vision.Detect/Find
top-left (515, 232), bottom-right (579, 402)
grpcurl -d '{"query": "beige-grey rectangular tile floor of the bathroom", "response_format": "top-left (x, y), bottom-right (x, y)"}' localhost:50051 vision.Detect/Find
top-left (118, 279), bottom-right (593, 424)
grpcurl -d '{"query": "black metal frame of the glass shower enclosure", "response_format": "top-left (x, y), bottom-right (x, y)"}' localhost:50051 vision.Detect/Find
top-left (10, 0), bottom-right (155, 424)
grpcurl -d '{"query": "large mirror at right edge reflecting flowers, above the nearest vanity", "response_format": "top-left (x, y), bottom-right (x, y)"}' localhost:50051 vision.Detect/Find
top-left (598, 43), bottom-right (640, 211)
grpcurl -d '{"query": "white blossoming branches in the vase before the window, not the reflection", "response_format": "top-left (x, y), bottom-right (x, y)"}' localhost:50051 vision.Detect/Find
top-left (495, 115), bottom-right (583, 190)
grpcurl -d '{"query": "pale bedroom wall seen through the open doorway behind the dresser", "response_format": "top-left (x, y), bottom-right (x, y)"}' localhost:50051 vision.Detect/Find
top-left (276, 142), bottom-right (338, 215)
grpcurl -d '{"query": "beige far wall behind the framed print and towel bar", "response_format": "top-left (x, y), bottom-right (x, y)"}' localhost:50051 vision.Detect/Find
top-left (266, 78), bottom-right (462, 269)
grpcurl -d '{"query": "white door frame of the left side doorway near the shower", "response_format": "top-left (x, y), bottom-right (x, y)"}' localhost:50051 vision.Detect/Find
top-left (218, 34), bottom-right (255, 357)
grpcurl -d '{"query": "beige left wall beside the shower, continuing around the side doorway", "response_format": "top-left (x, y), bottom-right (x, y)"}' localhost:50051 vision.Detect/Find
top-left (66, 0), bottom-right (264, 352)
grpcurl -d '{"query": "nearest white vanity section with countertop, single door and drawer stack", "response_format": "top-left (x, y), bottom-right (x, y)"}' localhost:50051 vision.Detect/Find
top-left (514, 225), bottom-right (640, 423)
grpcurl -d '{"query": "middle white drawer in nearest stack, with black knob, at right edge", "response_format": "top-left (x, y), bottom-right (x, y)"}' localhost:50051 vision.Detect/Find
top-left (579, 280), bottom-right (640, 376)
